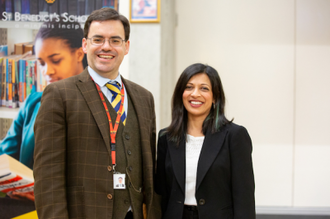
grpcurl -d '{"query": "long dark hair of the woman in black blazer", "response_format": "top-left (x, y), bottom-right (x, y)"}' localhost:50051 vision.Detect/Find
top-left (166, 63), bottom-right (232, 145)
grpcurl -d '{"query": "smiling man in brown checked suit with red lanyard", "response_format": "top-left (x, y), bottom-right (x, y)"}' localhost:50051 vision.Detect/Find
top-left (34, 8), bottom-right (160, 219)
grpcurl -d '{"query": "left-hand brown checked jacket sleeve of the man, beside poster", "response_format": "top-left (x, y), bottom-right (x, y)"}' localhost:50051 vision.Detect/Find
top-left (33, 83), bottom-right (68, 219)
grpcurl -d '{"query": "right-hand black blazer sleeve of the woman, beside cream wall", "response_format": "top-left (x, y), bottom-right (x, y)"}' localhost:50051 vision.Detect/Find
top-left (230, 126), bottom-right (256, 219)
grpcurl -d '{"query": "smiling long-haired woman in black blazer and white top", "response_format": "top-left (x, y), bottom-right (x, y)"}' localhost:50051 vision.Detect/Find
top-left (155, 63), bottom-right (255, 219)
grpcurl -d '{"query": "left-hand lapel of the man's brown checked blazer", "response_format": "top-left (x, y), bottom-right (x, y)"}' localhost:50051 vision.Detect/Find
top-left (77, 68), bottom-right (111, 157)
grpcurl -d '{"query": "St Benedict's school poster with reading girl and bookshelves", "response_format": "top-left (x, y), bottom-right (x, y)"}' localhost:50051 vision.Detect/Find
top-left (0, 0), bottom-right (118, 219)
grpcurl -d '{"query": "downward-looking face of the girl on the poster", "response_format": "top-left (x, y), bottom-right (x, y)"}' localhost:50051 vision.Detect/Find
top-left (35, 38), bottom-right (84, 84)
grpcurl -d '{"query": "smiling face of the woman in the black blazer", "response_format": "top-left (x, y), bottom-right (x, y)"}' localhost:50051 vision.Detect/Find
top-left (182, 73), bottom-right (214, 120)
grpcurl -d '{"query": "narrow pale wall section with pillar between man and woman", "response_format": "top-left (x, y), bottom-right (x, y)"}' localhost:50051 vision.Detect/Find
top-left (123, 0), bottom-right (175, 133)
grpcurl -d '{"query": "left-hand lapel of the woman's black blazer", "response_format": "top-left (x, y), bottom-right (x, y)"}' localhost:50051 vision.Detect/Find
top-left (167, 136), bottom-right (186, 193)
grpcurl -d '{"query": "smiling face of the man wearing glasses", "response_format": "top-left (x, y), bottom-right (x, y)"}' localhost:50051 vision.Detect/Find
top-left (83, 20), bottom-right (129, 79)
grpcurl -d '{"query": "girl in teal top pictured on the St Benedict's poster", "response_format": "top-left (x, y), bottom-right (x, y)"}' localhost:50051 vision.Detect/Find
top-left (0, 18), bottom-right (87, 199)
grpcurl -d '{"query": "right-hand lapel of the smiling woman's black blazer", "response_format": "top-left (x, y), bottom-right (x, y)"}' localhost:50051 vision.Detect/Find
top-left (196, 126), bottom-right (227, 190)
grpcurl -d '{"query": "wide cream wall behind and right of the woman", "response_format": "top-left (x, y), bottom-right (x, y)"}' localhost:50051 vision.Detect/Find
top-left (175, 0), bottom-right (330, 212)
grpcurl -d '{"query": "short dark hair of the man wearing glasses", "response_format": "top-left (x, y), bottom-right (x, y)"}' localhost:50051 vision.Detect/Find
top-left (84, 8), bottom-right (130, 41)
